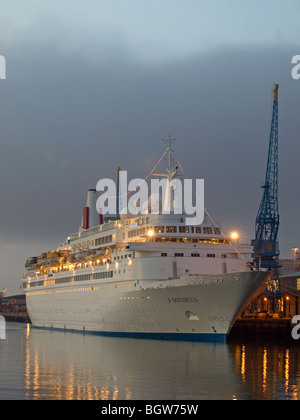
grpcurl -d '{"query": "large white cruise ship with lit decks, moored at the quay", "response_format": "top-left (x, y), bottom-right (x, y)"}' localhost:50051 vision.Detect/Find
top-left (22, 139), bottom-right (270, 342)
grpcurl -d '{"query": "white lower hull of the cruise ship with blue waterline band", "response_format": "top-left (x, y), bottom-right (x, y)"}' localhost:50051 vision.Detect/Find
top-left (26, 272), bottom-right (269, 342)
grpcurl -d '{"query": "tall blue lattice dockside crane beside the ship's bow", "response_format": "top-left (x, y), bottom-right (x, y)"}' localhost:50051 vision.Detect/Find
top-left (252, 84), bottom-right (280, 292)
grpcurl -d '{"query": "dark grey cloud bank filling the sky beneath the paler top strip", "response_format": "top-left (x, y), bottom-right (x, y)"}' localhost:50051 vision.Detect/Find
top-left (0, 18), bottom-right (300, 292)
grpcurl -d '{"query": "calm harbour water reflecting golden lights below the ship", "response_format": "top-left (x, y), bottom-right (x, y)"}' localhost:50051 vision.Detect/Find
top-left (0, 323), bottom-right (300, 400)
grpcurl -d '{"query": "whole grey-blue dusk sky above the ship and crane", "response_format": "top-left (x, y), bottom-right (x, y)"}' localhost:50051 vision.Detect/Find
top-left (0, 0), bottom-right (300, 294)
